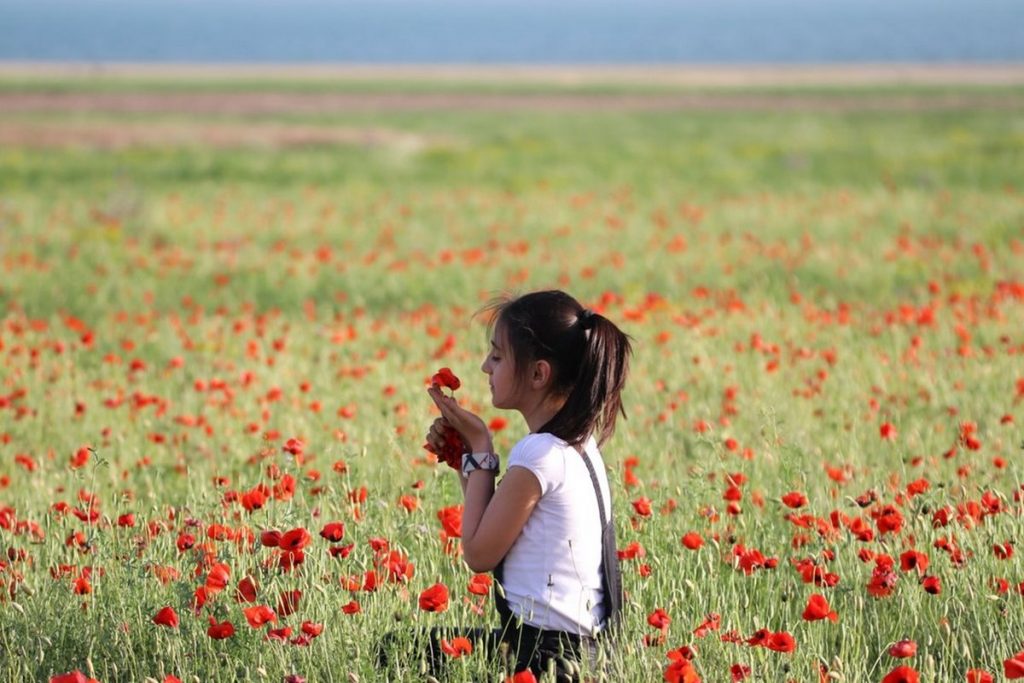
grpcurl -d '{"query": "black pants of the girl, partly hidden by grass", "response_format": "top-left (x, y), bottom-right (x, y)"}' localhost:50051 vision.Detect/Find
top-left (380, 622), bottom-right (601, 683)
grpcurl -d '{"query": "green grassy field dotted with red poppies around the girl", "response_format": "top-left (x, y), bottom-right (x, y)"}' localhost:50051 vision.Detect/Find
top-left (0, 72), bottom-right (1024, 683)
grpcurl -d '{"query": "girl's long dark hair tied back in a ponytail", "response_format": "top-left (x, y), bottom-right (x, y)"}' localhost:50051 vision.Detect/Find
top-left (484, 290), bottom-right (633, 446)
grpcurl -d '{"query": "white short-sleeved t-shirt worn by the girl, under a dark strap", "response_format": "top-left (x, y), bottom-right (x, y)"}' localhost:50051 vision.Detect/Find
top-left (503, 433), bottom-right (611, 636)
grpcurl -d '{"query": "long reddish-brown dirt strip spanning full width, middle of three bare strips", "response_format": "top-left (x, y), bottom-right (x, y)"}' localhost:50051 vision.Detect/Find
top-left (0, 92), bottom-right (1024, 115)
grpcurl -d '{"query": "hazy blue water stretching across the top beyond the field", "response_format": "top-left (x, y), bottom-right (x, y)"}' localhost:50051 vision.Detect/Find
top-left (0, 0), bottom-right (1024, 63)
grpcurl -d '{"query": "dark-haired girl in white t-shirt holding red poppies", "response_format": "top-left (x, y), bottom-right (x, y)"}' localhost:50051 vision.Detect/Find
top-left (419, 291), bottom-right (632, 680)
